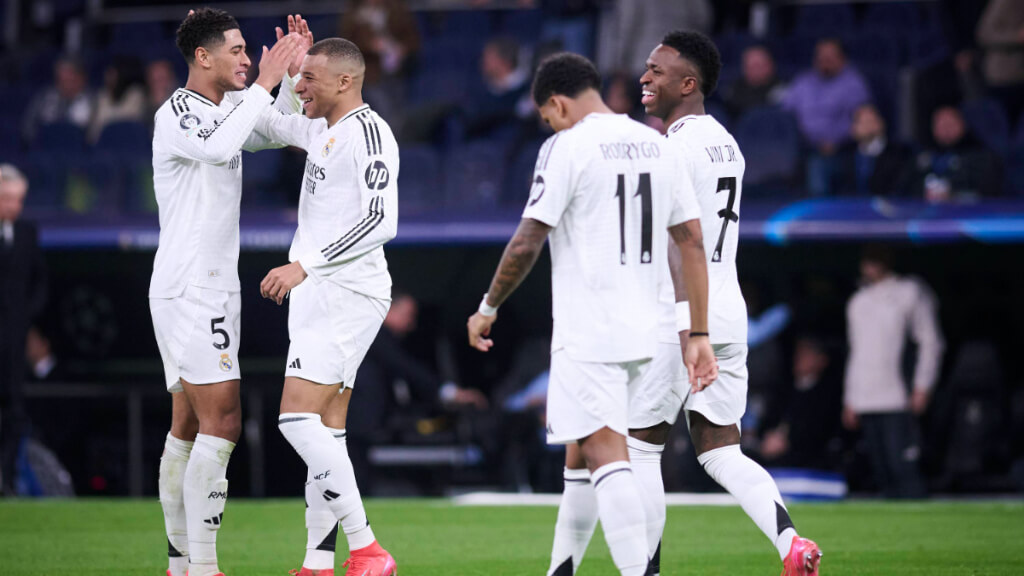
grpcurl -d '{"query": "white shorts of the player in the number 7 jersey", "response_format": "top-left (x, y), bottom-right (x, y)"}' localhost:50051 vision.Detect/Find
top-left (630, 342), bottom-right (748, 428)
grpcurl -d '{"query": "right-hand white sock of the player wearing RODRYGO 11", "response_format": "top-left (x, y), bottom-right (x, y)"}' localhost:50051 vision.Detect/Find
top-left (590, 461), bottom-right (647, 576)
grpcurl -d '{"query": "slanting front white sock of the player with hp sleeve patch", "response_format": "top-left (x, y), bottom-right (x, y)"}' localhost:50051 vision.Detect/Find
top-left (278, 412), bottom-right (375, 551)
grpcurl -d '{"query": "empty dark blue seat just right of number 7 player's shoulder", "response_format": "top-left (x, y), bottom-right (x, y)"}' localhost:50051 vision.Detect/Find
top-left (733, 108), bottom-right (800, 190)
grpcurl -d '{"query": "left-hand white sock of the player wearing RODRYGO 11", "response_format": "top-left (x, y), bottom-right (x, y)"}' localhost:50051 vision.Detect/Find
top-left (548, 468), bottom-right (597, 576)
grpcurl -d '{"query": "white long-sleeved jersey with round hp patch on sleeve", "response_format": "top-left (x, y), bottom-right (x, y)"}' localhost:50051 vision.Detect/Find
top-left (257, 105), bottom-right (398, 299)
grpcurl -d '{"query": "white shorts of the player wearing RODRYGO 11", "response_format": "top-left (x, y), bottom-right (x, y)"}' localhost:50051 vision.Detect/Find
top-left (547, 349), bottom-right (650, 444)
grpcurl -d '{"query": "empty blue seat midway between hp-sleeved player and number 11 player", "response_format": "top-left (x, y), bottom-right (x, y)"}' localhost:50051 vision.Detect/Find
top-left (444, 140), bottom-right (506, 212)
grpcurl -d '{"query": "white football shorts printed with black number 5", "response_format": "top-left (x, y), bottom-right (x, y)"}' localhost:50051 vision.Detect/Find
top-left (150, 286), bottom-right (242, 393)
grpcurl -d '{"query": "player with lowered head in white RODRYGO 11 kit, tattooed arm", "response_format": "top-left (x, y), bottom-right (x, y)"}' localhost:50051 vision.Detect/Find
top-left (467, 53), bottom-right (716, 576)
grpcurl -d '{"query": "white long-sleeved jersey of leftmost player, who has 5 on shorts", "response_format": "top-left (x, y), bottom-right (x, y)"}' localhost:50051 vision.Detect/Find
top-left (150, 79), bottom-right (299, 298)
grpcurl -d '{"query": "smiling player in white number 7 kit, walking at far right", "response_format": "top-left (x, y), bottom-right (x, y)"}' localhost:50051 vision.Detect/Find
top-left (630, 32), bottom-right (821, 575)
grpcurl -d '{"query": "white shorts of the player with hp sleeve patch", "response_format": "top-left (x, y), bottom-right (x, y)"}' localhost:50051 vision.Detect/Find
top-left (285, 279), bottom-right (391, 390)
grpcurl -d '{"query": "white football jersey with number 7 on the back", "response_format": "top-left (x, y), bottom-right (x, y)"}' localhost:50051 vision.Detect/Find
top-left (658, 115), bottom-right (746, 344)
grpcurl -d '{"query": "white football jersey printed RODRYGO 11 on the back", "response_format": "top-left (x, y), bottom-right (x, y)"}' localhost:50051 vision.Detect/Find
top-left (522, 114), bottom-right (700, 363)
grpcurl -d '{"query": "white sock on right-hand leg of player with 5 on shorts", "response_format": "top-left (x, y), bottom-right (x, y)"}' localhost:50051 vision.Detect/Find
top-left (182, 434), bottom-right (234, 576)
